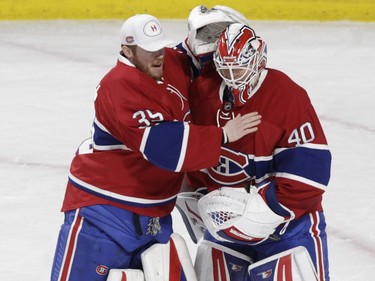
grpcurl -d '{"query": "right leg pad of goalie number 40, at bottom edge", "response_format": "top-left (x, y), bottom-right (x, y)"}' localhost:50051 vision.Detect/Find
top-left (246, 246), bottom-right (318, 281)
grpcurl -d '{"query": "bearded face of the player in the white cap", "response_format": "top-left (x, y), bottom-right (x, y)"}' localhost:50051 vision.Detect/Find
top-left (132, 46), bottom-right (164, 80)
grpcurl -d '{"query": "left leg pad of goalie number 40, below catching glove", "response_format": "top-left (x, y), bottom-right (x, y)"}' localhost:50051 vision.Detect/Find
top-left (194, 240), bottom-right (252, 281)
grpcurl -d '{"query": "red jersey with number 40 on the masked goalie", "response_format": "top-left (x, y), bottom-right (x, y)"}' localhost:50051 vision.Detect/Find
top-left (190, 69), bottom-right (331, 217)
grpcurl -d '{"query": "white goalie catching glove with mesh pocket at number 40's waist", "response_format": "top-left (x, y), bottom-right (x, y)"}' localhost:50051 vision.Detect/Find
top-left (198, 187), bottom-right (286, 244)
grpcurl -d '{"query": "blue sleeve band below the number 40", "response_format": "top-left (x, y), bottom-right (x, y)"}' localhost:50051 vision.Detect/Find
top-left (274, 146), bottom-right (331, 185)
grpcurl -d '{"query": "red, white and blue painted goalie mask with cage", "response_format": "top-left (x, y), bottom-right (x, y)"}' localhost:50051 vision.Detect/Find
top-left (213, 23), bottom-right (267, 106)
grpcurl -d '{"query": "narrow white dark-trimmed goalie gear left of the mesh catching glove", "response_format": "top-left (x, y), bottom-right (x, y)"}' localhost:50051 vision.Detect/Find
top-left (176, 192), bottom-right (206, 244)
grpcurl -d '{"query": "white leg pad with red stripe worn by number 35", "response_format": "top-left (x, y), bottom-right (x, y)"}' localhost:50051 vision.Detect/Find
top-left (141, 233), bottom-right (197, 281)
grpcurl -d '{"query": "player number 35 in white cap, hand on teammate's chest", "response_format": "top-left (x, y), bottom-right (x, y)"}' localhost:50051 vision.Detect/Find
top-left (51, 14), bottom-right (260, 281)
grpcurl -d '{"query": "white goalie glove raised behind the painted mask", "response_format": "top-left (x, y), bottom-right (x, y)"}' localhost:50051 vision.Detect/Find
top-left (188, 5), bottom-right (247, 56)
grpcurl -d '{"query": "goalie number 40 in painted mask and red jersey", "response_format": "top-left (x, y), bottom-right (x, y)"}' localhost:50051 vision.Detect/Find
top-left (190, 23), bottom-right (331, 281)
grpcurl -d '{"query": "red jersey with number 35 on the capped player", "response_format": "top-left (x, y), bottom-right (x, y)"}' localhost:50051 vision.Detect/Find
top-left (62, 49), bottom-right (222, 216)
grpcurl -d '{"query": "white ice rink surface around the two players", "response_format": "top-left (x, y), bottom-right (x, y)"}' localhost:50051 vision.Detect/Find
top-left (0, 20), bottom-right (375, 281)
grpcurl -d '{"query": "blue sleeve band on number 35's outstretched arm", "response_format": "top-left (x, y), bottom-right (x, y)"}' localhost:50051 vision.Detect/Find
top-left (142, 122), bottom-right (188, 171)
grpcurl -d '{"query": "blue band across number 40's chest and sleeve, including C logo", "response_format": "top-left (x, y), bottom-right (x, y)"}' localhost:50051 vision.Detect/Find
top-left (207, 144), bottom-right (331, 188)
